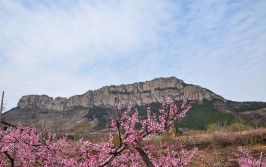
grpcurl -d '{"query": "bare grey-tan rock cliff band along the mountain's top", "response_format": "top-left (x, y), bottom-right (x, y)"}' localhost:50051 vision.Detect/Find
top-left (18, 77), bottom-right (224, 111)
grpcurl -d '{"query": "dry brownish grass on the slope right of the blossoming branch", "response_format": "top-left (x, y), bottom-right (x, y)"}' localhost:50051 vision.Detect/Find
top-left (143, 128), bottom-right (266, 166)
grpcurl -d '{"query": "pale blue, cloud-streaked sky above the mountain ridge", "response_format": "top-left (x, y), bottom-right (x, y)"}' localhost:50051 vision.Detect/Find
top-left (0, 0), bottom-right (266, 110)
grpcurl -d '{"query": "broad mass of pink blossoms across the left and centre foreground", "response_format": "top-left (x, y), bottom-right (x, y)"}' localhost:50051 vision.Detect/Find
top-left (0, 99), bottom-right (197, 167)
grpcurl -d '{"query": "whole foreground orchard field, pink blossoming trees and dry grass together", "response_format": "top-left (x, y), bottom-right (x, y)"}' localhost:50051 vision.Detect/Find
top-left (0, 99), bottom-right (266, 167)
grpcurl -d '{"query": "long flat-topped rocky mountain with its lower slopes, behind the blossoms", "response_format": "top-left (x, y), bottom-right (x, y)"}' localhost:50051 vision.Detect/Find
top-left (3, 77), bottom-right (266, 131)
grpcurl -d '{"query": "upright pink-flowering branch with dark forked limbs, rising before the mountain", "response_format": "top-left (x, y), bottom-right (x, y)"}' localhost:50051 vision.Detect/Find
top-left (101, 99), bottom-right (195, 167)
